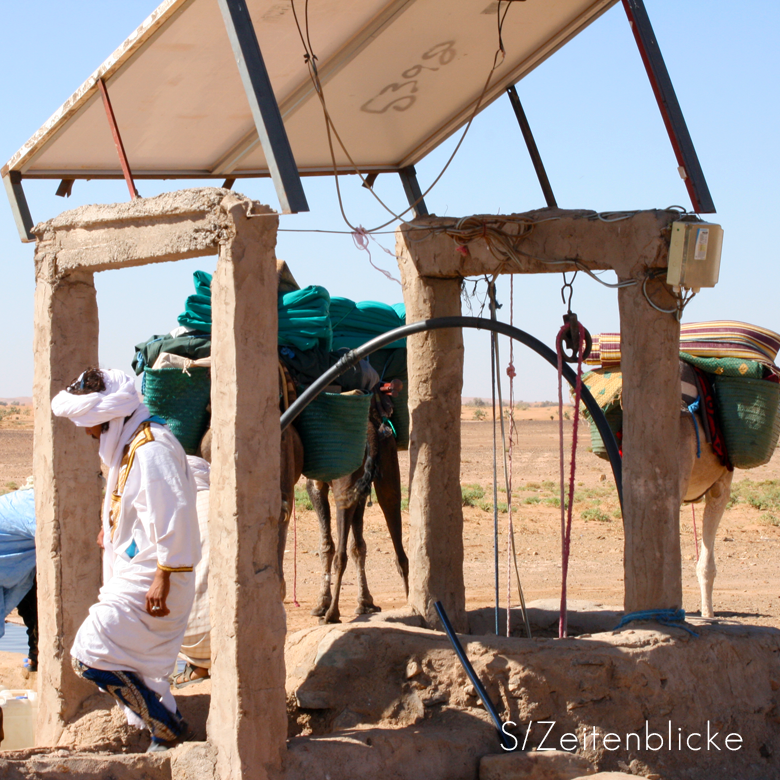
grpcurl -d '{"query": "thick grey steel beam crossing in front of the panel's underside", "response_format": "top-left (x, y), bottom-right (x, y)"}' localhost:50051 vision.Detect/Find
top-left (219, 0), bottom-right (309, 214)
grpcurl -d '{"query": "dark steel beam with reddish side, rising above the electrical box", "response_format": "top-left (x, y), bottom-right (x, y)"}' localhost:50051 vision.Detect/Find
top-left (623, 0), bottom-right (715, 214)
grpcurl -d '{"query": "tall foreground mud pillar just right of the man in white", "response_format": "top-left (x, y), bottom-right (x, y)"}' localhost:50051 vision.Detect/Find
top-left (208, 197), bottom-right (287, 780)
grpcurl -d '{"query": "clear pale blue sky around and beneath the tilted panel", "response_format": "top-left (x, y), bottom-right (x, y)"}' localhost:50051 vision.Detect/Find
top-left (0, 0), bottom-right (780, 401)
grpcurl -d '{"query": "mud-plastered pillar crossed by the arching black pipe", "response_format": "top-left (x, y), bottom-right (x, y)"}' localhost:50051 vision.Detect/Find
top-left (397, 241), bottom-right (468, 631)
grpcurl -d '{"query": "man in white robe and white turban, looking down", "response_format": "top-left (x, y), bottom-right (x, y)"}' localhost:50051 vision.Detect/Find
top-left (52, 369), bottom-right (200, 751)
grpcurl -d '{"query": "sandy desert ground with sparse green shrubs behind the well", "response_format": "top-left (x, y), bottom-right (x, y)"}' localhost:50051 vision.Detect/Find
top-left (0, 399), bottom-right (780, 644)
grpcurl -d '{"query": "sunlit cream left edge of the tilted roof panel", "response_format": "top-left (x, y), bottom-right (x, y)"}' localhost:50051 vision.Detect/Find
top-left (2, 0), bottom-right (193, 176)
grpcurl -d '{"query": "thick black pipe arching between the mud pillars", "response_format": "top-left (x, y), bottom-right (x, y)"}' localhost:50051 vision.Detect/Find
top-left (281, 317), bottom-right (623, 510)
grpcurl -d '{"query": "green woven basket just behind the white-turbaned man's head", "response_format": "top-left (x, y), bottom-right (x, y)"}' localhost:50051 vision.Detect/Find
top-left (143, 367), bottom-right (211, 455)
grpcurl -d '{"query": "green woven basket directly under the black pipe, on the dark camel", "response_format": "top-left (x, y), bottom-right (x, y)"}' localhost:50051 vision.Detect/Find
top-left (295, 393), bottom-right (371, 482)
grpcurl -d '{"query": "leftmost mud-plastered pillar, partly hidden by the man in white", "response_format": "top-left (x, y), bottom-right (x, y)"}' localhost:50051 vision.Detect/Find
top-left (33, 268), bottom-right (101, 745)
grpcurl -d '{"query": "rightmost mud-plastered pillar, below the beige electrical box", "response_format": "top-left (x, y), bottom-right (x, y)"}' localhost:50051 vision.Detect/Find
top-left (618, 281), bottom-right (682, 612)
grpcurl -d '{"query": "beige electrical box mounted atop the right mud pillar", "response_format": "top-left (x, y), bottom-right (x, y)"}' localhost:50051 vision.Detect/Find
top-left (666, 222), bottom-right (723, 292)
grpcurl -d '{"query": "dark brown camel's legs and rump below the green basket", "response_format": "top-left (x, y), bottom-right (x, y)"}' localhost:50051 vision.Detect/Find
top-left (306, 392), bottom-right (409, 623)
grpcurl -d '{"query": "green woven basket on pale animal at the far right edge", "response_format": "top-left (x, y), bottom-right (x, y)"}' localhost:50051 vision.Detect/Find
top-left (713, 376), bottom-right (780, 469)
